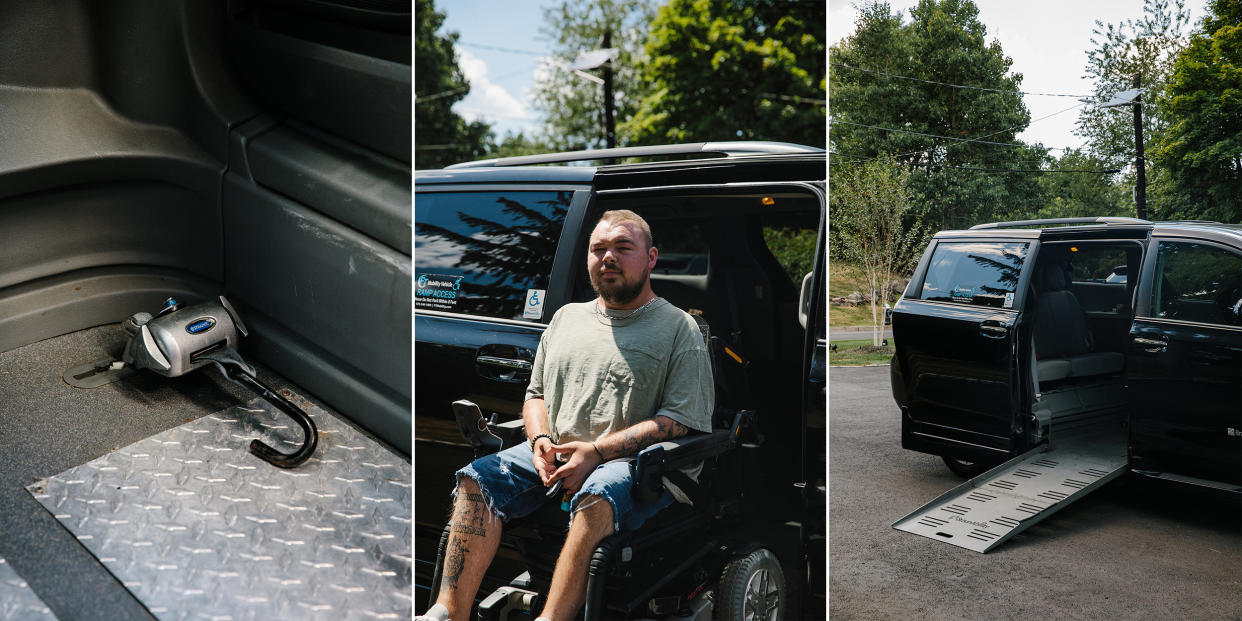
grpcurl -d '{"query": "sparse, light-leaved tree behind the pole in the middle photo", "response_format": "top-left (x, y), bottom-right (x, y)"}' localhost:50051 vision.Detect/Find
top-left (532, 0), bottom-right (653, 150)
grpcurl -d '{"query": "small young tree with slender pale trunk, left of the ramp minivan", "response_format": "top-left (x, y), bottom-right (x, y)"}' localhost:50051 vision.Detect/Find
top-left (828, 155), bottom-right (927, 347)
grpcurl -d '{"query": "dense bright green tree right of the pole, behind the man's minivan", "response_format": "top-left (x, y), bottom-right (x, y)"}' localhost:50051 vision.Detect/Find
top-left (619, 0), bottom-right (826, 147)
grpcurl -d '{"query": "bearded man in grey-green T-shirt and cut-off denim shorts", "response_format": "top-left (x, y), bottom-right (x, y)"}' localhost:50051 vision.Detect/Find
top-left (419, 210), bottom-right (714, 621)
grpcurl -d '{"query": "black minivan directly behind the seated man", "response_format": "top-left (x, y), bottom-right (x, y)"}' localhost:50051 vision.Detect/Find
top-left (414, 143), bottom-right (826, 619)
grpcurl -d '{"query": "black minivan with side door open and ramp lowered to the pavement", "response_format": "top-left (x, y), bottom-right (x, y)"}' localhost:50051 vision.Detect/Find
top-left (891, 217), bottom-right (1242, 493)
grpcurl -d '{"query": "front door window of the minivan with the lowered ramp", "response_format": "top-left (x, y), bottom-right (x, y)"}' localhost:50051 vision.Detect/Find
top-left (1151, 241), bottom-right (1242, 325)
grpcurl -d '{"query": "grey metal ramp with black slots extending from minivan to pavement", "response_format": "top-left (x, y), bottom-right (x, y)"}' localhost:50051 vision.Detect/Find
top-left (893, 433), bottom-right (1126, 553)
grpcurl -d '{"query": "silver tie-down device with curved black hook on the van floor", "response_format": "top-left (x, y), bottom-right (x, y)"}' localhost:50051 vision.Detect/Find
top-left (122, 296), bottom-right (319, 468)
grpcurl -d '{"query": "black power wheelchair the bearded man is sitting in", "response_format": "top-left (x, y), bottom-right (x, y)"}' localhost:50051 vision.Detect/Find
top-left (428, 337), bottom-right (804, 621)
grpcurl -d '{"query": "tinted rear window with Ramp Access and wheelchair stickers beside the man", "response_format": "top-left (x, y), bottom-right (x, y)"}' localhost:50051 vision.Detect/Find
top-left (414, 191), bottom-right (573, 319)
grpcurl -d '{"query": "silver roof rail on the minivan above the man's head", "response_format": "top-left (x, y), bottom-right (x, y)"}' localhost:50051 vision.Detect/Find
top-left (445, 140), bottom-right (825, 168)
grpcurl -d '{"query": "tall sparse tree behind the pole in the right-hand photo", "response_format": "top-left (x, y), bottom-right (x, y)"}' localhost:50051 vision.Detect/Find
top-left (1074, 0), bottom-right (1190, 215)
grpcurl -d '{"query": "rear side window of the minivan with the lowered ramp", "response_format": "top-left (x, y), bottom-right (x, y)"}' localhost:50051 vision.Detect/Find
top-left (919, 242), bottom-right (1027, 308)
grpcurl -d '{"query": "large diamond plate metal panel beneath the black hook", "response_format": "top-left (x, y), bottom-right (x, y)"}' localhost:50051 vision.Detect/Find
top-left (27, 391), bottom-right (412, 621)
